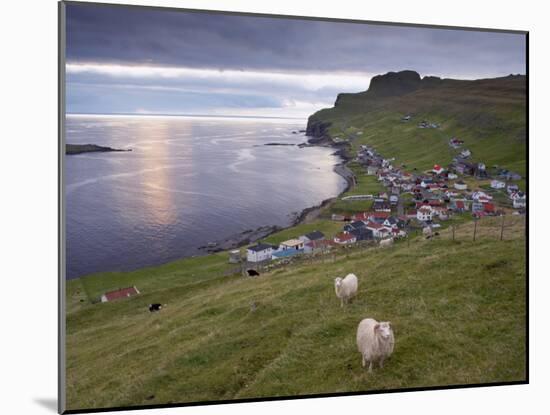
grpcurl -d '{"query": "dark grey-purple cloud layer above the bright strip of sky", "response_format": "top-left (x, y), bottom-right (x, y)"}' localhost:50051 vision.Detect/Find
top-left (67, 4), bottom-right (525, 78)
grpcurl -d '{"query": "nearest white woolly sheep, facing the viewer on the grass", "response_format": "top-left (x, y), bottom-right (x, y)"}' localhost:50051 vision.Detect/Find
top-left (357, 318), bottom-right (395, 372)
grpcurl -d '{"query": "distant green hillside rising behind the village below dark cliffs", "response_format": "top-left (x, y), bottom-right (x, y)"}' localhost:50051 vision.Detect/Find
top-left (308, 75), bottom-right (527, 186)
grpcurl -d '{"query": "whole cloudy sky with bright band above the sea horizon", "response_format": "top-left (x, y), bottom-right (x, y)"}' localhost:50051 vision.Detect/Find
top-left (66, 4), bottom-right (525, 118)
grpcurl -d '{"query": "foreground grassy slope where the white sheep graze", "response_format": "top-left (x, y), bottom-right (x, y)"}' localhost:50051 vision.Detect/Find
top-left (67, 218), bottom-right (526, 409)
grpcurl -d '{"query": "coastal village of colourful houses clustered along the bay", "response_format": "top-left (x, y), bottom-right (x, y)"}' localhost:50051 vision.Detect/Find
top-left (240, 115), bottom-right (527, 266)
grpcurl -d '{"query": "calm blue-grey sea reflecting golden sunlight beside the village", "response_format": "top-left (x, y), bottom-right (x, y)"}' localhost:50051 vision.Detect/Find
top-left (65, 115), bottom-right (346, 279)
